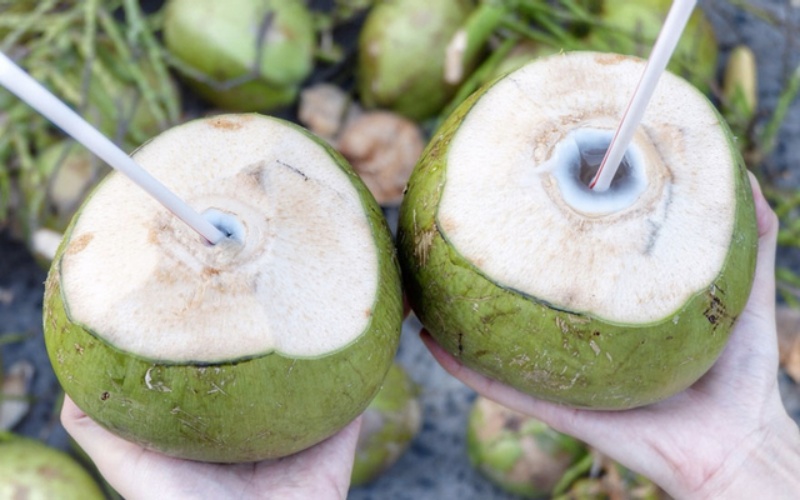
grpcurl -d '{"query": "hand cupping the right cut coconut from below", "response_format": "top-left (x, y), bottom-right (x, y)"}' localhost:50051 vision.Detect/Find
top-left (422, 173), bottom-right (800, 499)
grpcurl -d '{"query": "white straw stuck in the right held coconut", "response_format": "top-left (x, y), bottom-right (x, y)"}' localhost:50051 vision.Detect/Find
top-left (589, 0), bottom-right (697, 191)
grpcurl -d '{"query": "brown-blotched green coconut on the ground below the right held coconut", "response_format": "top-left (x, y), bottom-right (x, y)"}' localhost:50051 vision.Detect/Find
top-left (467, 397), bottom-right (588, 498)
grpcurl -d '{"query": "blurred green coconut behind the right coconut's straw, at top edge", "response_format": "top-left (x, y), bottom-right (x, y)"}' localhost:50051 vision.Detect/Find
top-left (587, 0), bottom-right (719, 93)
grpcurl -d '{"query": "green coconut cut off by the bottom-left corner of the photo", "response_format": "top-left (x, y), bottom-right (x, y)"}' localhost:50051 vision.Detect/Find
top-left (0, 433), bottom-right (105, 500)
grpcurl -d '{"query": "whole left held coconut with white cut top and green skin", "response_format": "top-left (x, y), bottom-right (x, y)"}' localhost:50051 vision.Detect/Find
top-left (44, 115), bottom-right (402, 462)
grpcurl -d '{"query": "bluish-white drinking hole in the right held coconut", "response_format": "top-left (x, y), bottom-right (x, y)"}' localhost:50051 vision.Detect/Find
top-left (545, 128), bottom-right (647, 215)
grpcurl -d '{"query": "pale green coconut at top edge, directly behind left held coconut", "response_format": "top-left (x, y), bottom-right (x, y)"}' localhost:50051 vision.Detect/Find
top-left (164, 0), bottom-right (316, 111)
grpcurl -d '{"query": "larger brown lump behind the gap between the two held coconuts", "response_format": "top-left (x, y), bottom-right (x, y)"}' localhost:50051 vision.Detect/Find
top-left (337, 111), bottom-right (425, 205)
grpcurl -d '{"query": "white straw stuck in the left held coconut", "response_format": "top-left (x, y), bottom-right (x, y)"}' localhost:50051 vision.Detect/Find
top-left (0, 52), bottom-right (225, 244)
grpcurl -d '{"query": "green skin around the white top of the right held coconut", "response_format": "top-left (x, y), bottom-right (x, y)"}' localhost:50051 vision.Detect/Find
top-left (398, 66), bottom-right (758, 409)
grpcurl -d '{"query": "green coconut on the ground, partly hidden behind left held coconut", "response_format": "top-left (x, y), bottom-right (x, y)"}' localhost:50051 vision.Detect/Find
top-left (350, 363), bottom-right (422, 486)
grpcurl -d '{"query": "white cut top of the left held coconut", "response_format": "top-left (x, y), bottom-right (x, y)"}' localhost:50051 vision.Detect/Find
top-left (61, 115), bottom-right (379, 362)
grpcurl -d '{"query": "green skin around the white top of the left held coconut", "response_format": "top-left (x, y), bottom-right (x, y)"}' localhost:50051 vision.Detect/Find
top-left (43, 117), bottom-right (403, 463)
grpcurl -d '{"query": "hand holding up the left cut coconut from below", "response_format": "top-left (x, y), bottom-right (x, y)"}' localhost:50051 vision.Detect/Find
top-left (61, 397), bottom-right (361, 500)
